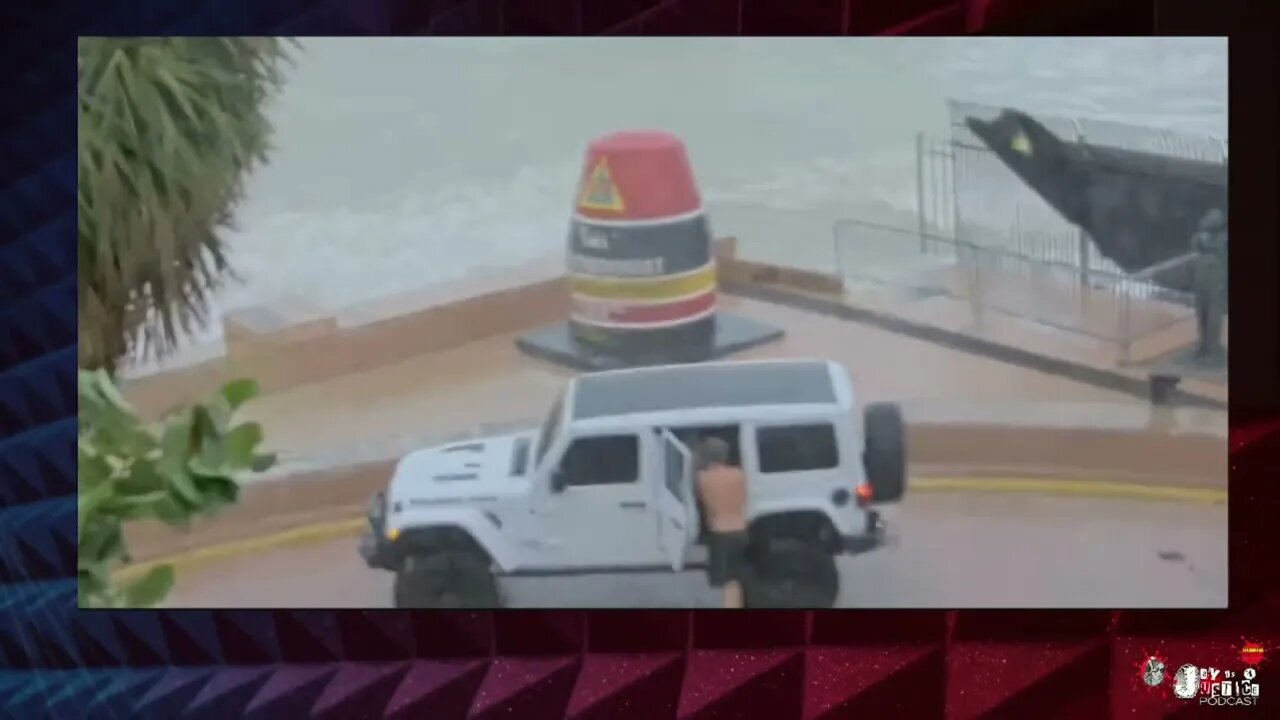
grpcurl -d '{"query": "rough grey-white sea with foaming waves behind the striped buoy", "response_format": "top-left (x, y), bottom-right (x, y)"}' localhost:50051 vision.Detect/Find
top-left (194, 38), bottom-right (1226, 345)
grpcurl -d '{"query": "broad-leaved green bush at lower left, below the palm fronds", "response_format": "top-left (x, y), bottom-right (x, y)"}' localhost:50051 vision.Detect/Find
top-left (78, 370), bottom-right (275, 607)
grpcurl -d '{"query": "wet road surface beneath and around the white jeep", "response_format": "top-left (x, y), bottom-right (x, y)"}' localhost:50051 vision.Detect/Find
top-left (169, 493), bottom-right (1228, 609)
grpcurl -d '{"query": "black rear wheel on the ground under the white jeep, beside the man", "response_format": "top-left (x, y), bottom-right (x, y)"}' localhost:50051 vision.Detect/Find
top-left (742, 539), bottom-right (840, 609)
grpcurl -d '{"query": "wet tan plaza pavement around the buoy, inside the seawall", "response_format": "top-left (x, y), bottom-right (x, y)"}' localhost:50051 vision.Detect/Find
top-left (235, 297), bottom-right (1144, 457)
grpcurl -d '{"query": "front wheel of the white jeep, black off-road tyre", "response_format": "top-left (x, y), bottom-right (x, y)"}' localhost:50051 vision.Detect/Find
top-left (393, 550), bottom-right (502, 610)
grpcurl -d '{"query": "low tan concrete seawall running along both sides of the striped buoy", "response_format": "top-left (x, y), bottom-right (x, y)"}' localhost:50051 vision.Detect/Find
top-left (123, 237), bottom-right (1226, 418)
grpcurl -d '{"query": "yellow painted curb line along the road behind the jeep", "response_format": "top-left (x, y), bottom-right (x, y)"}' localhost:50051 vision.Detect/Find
top-left (115, 478), bottom-right (1226, 580)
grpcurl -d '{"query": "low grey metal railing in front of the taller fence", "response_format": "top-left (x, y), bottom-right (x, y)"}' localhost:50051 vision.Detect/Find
top-left (833, 220), bottom-right (1194, 365)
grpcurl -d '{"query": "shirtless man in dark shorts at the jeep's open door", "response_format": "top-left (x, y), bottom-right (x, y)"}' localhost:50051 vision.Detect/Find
top-left (698, 437), bottom-right (746, 609)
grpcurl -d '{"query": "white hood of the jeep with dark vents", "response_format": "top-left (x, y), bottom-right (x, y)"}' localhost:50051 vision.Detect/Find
top-left (389, 432), bottom-right (535, 505)
